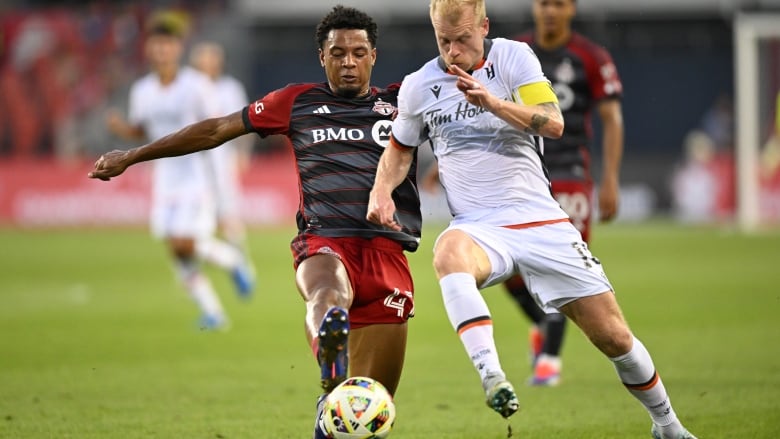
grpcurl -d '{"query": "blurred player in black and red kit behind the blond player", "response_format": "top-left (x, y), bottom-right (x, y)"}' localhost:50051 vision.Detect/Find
top-left (504, 0), bottom-right (623, 386)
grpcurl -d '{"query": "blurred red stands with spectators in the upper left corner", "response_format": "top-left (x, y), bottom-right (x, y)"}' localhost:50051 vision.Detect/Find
top-left (0, 0), bottom-right (226, 160)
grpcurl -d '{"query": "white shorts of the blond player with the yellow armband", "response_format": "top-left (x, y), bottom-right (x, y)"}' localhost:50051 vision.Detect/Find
top-left (439, 222), bottom-right (613, 313)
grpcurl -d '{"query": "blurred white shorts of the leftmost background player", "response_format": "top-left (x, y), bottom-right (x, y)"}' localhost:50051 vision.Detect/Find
top-left (150, 195), bottom-right (217, 239)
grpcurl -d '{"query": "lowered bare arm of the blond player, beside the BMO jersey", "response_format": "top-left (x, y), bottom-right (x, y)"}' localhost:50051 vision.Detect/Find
top-left (366, 139), bottom-right (414, 231)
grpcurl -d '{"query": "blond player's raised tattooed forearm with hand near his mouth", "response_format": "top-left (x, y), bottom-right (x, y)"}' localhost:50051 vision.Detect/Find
top-left (450, 65), bottom-right (563, 139)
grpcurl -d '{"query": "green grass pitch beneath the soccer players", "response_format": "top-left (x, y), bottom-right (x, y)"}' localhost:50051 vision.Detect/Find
top-left (0, 224), bottom-right (780, 439)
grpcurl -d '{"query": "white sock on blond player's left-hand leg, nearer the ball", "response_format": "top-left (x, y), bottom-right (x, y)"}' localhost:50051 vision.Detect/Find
top-left (439, 273), bottom-right (504, 380)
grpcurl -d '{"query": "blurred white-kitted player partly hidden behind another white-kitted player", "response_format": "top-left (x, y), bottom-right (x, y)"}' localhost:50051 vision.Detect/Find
top-left (190, 41), bottom-right (253, 272)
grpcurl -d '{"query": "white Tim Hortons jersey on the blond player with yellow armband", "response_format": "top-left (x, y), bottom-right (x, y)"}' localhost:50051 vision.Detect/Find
top-left (393, 38), bottom-right (567, 225)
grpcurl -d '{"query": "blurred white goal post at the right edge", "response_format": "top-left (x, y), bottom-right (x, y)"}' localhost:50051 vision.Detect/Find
top-left (734, 13), bottom-right (780, 232)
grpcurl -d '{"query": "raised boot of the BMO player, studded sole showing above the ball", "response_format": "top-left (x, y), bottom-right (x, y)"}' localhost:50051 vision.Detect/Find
top-left (317, 306), bottom-right (349, 393)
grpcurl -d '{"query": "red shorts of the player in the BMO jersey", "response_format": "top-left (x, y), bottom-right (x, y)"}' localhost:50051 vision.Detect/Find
top-left (290, 234), bottom-right (414, 329)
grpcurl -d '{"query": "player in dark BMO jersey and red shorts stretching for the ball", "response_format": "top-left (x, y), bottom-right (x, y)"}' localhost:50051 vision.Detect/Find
top-left (89, 6), bottom-right (422, 438)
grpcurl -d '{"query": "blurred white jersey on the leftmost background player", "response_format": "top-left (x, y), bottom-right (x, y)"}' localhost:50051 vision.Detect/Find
top-left (129, 67), bottom-right (219, 202)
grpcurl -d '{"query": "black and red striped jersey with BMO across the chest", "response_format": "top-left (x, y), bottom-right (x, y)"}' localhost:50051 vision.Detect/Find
top-left (243, 83), bottom-right (422, 251)
